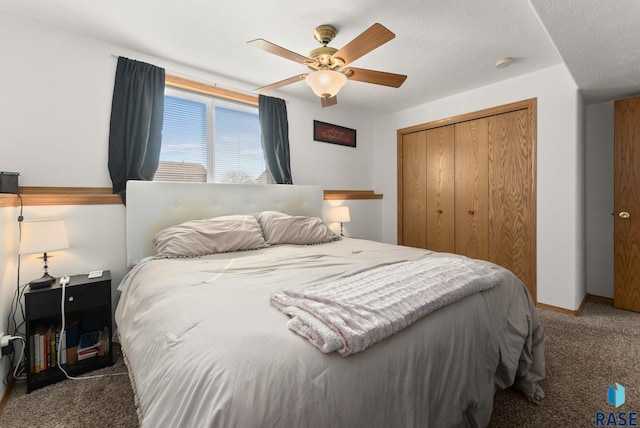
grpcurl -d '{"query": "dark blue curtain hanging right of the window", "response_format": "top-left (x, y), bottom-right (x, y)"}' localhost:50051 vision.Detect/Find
top-left (258, 95), bottom-right (293, 184)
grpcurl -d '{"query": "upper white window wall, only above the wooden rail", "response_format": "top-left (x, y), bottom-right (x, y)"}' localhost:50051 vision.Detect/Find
top-left (0, 15), bottom-right (373, 189)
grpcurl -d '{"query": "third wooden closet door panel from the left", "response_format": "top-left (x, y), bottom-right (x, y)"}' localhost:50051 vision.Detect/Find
top-left (455, 118), bottom-right (489, 260)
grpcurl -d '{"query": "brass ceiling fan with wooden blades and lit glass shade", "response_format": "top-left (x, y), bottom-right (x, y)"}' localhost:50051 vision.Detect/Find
top-left (247, 23), bottom-right (407, 107)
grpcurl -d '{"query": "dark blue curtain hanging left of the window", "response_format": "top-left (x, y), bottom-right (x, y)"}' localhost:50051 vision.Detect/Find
top-left (109, 57), bottom-right (164, 203)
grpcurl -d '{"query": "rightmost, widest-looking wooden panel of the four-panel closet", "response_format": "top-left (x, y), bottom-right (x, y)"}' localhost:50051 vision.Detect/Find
top-left (488, 110), bottom-right (536, 299)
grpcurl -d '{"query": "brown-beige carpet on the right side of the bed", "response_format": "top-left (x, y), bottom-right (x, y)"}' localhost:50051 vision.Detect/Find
top-left (490, 301), bottom-right (640, 427)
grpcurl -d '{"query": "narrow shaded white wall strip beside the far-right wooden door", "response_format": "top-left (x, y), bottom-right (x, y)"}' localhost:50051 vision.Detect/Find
top-left (585, 101), bottom-right (614, 298)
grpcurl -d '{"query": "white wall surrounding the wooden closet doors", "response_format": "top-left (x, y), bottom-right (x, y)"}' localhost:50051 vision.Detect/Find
top-left (373, 65), bottom-right (585, 310)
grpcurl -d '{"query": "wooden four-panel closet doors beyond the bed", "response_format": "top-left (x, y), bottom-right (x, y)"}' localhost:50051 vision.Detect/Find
top-left (398, 99), bottom-right (536, 300)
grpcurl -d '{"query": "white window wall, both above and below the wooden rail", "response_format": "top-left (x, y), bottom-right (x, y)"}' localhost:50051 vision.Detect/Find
top-left (0, 14), bottom-right (381, 392)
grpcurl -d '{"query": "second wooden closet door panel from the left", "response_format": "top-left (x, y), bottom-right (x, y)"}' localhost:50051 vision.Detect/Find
top-left (426, 125), bottom-right (455, 253)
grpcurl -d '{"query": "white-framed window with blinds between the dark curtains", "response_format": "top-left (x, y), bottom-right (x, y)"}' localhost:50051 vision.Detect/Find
top-left (154, 87), bottom-right (273, 184)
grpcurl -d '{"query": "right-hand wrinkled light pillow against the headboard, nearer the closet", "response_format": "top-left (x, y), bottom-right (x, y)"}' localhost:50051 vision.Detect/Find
top-left (258, 211), bottom-right (341, 245)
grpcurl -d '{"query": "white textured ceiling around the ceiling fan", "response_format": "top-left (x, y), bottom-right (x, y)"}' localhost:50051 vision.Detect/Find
top-left (0, 0), bottom-right (640, 116)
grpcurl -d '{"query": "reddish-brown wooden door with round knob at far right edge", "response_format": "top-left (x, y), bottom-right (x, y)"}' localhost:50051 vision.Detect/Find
top-left (613, 97), bottom-right (640, 312)
